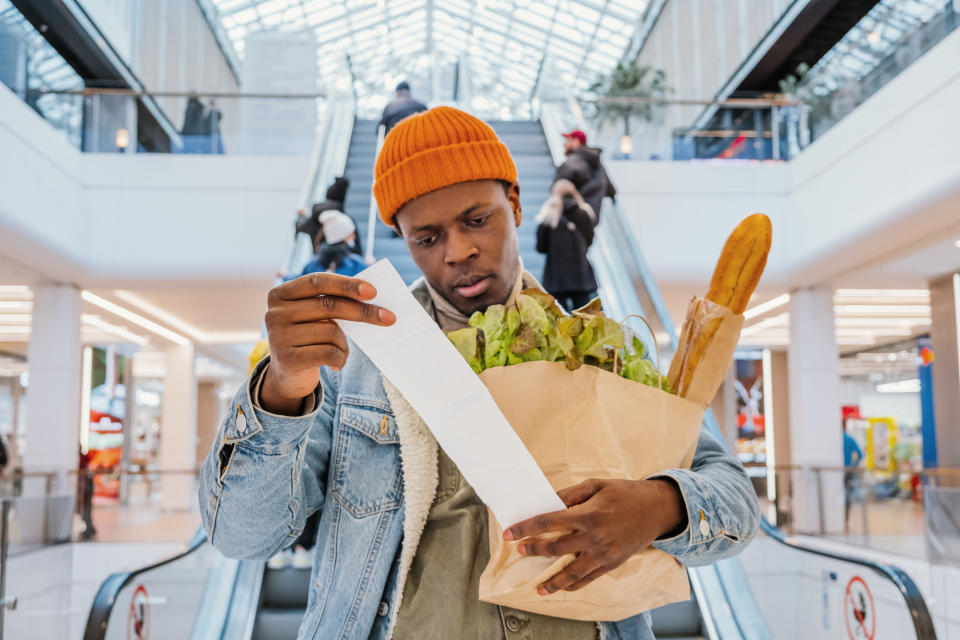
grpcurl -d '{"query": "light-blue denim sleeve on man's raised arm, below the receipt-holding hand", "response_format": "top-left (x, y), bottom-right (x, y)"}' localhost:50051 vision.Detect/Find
top-left (199, 358), bottom-right (337, 559)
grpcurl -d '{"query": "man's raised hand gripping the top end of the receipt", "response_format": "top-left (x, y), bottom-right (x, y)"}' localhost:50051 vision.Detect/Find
top-left (260, 273), bottom-right (396, 415)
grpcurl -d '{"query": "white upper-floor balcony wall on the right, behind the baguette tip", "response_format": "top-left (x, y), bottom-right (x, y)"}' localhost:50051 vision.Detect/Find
top-left (608, 31), bottom-right (960, 322)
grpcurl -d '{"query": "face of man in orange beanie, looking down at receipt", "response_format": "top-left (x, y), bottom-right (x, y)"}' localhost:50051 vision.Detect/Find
top-left (396, 180), bottom-right (523, 315)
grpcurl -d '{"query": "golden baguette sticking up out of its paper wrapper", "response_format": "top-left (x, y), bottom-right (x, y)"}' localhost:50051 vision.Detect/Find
top-left (667, 213), bottom-right (773, 397)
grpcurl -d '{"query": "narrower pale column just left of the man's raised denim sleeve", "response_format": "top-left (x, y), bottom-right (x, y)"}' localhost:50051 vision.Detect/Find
top-left (160, 345), bottom-right (197, 509)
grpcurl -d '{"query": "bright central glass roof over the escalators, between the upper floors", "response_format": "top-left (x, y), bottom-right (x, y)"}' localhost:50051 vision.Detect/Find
top-left (205, 0), bottom-right (649, 114)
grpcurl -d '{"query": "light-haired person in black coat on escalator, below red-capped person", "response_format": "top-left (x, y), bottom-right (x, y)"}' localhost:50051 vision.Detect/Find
top-left (536, 180), bottom-right (597, 311)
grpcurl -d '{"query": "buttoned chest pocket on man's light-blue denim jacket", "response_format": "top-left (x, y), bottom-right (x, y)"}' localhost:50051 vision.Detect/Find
top-left (332, 399), bottom-right (403, 518)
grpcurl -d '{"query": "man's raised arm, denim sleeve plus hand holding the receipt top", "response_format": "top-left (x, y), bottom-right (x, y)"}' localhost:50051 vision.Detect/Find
top-left (200, 273), bottom-right (396, 559)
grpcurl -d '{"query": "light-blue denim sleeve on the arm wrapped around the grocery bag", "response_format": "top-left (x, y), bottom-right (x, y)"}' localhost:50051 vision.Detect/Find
top-left (651, 426), bottom-right (760, 566)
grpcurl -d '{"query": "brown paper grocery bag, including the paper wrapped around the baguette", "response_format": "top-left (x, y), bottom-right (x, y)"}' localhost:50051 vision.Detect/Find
top-left (480, 307), bottom-right (742, 622)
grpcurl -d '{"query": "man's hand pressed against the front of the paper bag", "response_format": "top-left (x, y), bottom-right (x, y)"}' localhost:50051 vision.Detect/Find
top-left (503, 478), bottom-right (687, 596)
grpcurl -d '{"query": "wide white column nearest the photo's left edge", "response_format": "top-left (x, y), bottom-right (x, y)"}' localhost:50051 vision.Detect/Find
top-left (23, 284), bottom-right (83, 493)
